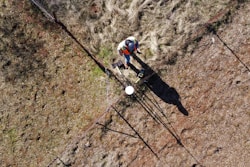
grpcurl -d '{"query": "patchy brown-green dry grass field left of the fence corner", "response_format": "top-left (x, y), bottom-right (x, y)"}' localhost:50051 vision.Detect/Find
top-left (0, 1), bottom-right (112, 166)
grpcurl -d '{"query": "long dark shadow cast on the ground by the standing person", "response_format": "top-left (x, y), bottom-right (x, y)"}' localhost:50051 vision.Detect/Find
top-left (129, 54), bottom-right (188, 116)
